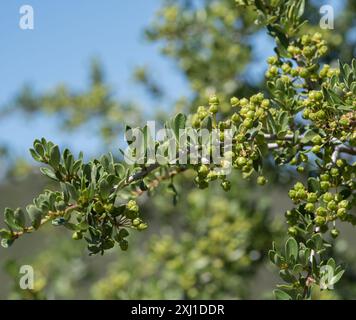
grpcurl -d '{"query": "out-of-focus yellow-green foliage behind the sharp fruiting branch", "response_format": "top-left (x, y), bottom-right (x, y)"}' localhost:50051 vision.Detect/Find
top-left (0, 0), bottom-right (356, 299)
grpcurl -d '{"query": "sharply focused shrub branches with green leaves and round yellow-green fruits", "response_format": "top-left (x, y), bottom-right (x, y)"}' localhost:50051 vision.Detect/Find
top-left (0, 0), bottom-right (356, 299)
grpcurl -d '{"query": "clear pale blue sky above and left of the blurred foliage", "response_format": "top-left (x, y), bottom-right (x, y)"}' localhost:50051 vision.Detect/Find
top-left (0, 0), bottom-right (188, 160)
